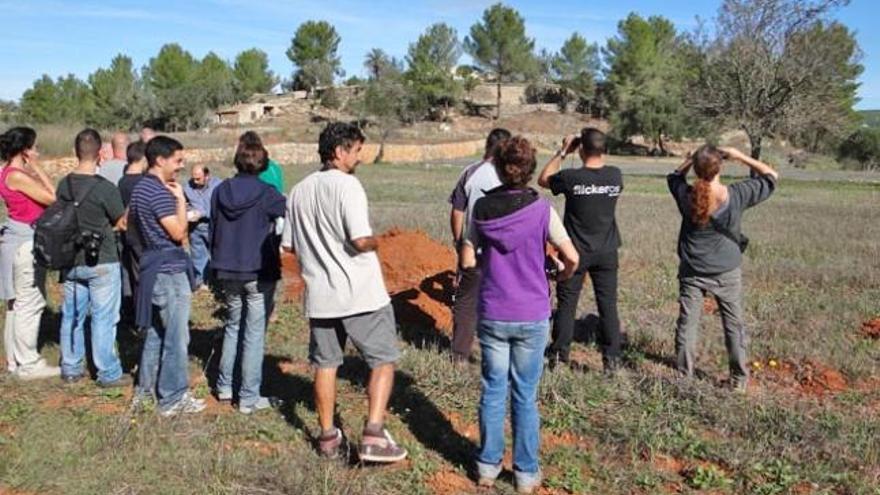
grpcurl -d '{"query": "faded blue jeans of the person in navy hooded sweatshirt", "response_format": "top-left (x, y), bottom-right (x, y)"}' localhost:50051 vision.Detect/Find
top-left (217, 280), bottom-right (275, 406)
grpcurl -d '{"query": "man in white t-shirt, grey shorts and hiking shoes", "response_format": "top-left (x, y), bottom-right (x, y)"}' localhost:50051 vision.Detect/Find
top-left (282, 122), bottom-right (407, 462)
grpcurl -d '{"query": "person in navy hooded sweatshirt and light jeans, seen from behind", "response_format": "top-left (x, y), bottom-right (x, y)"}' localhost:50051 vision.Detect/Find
top-left (210, 136), bottom-right (285, 414)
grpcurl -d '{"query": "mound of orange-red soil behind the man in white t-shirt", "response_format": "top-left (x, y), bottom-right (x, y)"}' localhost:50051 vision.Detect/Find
top-left (281, 228), bottom-right (455, 332)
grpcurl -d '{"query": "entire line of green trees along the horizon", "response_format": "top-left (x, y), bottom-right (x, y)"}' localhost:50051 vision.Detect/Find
top-left (0, 0), bottom-right (863, 167)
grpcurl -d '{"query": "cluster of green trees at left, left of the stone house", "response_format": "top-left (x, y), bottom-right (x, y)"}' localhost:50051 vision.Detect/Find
top-left (5, 43), bottom-right (277, 131)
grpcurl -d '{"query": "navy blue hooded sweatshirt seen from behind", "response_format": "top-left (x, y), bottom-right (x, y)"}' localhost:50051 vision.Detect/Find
top-left (211, 173), bottom-right (285, 281)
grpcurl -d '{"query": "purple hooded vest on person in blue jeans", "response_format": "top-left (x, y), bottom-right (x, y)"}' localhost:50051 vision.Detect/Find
top-left (474, 198), bottom-right (550, 322)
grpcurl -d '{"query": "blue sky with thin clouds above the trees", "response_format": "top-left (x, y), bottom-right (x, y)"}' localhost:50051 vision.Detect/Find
top-left (0, 0), bottom-right (880, 109)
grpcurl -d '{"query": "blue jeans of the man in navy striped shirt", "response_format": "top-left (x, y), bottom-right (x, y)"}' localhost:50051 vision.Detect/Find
top-left (137, 273), bottom-right (192, 408)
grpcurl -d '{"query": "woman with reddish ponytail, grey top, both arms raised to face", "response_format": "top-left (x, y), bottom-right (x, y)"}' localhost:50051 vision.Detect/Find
top-left (667, 146), bottom-right (778, 391)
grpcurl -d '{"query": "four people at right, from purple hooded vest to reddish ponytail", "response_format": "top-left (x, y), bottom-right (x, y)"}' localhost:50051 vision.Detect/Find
top-left (449, 128), bottom-right (778, 493)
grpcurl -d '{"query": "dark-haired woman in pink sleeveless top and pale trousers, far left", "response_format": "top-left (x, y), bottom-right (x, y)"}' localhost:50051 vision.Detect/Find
top-left (0, 127), bottom-right (60, 379)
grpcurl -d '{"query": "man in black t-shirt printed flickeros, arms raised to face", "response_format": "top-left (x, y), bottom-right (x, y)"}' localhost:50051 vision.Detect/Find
top-left (538, 128), bottom-right (623, 374)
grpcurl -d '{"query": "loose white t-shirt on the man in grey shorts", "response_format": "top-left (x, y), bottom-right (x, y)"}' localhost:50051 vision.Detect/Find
top-left (281, 170), bottom-right (391, 318)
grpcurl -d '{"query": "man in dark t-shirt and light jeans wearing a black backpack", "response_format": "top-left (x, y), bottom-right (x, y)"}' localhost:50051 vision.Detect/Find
top-left (57, 129), bottom-right (132, 387)
